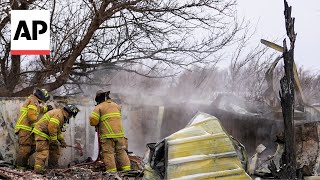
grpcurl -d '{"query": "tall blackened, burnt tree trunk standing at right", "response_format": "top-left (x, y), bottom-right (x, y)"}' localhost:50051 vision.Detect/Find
top-left (270, 0), bottom-right (301, 179)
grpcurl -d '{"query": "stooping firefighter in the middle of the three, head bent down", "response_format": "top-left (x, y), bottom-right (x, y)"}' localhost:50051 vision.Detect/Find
top-left (32, 104), bottom-right (79, 174)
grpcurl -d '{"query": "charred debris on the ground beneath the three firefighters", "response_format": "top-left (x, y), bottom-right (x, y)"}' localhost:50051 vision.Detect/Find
top-left (0, 153), bottom-right (144, 180)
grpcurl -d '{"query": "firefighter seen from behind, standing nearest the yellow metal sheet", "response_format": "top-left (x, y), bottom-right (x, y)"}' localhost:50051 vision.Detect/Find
top-left (90, 90), bottom-right (131, 172)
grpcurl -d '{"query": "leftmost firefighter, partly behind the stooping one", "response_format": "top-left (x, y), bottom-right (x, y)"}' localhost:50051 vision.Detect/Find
top-left (14, 88), bottom-right (52, 169)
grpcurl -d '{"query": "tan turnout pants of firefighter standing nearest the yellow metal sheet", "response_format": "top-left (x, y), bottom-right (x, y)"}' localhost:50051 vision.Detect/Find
top-left (100, 137), bottom-right (131, 172)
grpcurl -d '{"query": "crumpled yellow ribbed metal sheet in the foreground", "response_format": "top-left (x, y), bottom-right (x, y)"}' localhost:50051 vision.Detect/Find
top-left (166, 112), bottom-right (251, 180)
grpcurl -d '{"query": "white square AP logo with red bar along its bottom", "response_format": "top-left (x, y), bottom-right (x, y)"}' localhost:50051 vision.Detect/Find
top-left (11, 10), bottom-right (50, 55)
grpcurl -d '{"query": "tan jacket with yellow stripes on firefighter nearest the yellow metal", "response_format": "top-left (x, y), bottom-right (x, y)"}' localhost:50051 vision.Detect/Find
top-left (90, 100), bottom-right (124, 139)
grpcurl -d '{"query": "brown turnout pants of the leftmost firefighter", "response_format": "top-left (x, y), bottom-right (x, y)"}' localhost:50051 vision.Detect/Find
top-left (16, 129), bottom-right (35, 168)
